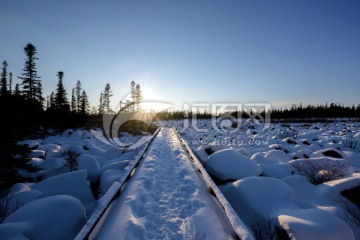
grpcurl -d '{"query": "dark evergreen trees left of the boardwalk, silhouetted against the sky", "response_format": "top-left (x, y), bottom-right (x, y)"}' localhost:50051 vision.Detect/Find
top-left (0, 43), bottom-right (142, 189)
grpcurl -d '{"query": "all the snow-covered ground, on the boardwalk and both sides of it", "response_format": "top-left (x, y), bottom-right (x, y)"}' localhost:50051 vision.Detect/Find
top-left (0, 119), bottom-right (360, 239)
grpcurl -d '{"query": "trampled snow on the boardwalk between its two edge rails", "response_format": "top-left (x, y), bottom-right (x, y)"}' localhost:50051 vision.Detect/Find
top-left (91, 129), bottom-right (234, 240)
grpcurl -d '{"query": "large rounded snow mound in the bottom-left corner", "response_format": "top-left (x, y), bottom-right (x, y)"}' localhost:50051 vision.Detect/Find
top-left (0, 196), bottom-right (85, 240)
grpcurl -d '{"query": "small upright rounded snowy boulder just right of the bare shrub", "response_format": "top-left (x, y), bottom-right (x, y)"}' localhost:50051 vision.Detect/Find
top-left (76, 154), bottom-right (101, 181)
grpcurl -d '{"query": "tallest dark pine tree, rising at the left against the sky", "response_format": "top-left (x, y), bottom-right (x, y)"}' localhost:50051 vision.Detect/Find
top-left (18, 43), bottom-right (44, 106)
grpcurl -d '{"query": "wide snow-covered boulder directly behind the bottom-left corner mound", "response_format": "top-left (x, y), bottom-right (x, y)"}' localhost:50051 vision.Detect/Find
top-left (32, 170), bottom-right (97, 214)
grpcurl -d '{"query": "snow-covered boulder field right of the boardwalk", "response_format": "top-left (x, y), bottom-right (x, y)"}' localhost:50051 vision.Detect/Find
top-left (158, 119), bottom-right (360, 239)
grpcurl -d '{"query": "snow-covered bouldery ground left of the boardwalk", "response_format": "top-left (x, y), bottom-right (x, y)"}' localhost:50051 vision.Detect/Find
top-left (0, 130), bottom-right (150, 240)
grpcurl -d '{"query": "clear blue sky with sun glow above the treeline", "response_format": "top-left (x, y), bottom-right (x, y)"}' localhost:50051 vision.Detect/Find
top-left (0, 0), bottom-right (360, 109)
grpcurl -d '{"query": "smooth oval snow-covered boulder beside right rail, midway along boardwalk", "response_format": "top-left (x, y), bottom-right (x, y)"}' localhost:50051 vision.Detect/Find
top-left (206, 149), bottom-right (261, 181)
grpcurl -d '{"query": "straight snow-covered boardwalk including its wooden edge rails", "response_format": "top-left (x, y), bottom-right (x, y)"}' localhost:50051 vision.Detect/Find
top-left (76, 128), bottom-right (253, 240)
